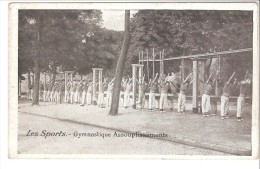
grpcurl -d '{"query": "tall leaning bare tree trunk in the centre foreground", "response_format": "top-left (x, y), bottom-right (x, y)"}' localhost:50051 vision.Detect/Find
top-left (109, 10), bottom-right (130, 116)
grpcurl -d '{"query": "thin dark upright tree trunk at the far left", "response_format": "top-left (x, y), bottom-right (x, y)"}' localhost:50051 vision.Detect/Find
top-left (32, 14), bottom-right (43, 105)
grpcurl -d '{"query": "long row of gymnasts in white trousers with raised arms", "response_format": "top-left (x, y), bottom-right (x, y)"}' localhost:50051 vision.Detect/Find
top-left (26, 73), bottom-right (251, 121)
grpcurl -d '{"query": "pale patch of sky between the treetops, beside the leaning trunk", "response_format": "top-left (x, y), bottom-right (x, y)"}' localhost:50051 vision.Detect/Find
top-left (102, 10), bottom-right (137, 31)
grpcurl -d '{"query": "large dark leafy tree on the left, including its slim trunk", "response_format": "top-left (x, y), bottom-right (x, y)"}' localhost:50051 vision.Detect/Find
top-left (18, 10), bottom-right (105, 105)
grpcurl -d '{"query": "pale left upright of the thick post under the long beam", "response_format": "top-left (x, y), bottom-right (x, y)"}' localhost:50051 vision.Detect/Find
top-left (192, 60), bottom-right (198, 113)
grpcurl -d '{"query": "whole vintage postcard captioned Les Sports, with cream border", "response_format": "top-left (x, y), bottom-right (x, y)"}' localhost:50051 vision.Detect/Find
top-left (9, 2), bottom-right (259, 159)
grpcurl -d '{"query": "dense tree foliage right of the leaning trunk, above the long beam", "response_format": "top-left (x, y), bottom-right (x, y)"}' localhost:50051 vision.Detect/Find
top-left (127, 10), bottom-right (253, 82)
